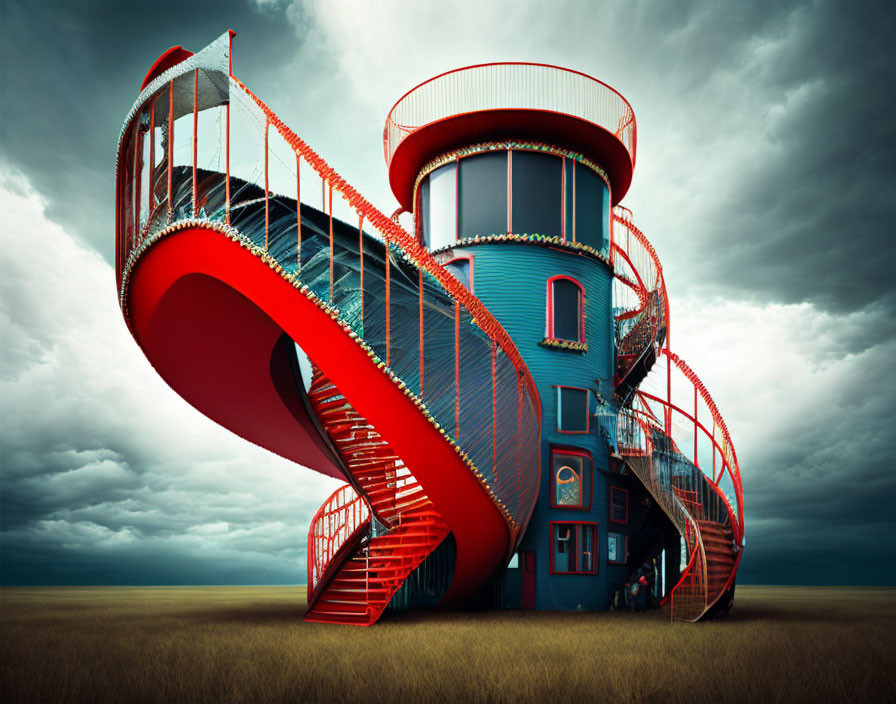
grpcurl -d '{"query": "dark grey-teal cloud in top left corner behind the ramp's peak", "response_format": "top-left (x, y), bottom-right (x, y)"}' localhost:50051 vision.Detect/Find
top-left (0, 0), bottom-right (297, 261)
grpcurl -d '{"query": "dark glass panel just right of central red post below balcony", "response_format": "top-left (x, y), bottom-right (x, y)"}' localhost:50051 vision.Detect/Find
top-left (512, 150), bottom-right (563, 237)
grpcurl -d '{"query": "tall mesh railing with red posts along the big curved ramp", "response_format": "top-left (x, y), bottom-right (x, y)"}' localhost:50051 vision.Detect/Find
top-left (116, 35), bottom-right (541, 564)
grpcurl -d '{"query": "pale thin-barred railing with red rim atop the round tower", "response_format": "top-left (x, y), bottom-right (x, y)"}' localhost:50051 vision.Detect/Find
top-left (383, 62), bottom-right (638, 166)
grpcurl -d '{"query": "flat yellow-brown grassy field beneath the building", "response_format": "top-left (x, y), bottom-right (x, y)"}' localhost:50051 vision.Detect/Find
top-left (0, 587), bottom-right (896, 704)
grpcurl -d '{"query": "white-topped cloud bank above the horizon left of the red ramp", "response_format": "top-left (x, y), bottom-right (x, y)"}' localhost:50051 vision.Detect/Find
top-left (0, 173), bottom-right (338, 584)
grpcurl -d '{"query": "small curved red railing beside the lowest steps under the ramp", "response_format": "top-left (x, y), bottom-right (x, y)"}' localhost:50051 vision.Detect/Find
top-left (308, 484), bottom-right (370, 602)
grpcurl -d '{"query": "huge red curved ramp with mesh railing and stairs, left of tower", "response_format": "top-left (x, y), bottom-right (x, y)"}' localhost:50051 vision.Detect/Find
top-left (117, 35), bottom-right (540, 624)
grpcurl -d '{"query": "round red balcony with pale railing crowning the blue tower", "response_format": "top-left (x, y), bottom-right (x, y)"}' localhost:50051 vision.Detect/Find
top-left (383, 63), bottom-right (637, 210)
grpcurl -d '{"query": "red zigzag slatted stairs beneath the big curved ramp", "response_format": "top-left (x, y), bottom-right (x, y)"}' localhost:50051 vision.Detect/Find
top-left (305, 368), bottom-right (448, 626)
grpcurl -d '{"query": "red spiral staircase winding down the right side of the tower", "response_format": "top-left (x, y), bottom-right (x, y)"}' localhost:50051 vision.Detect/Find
top-left (611, 207), bottom-right (744, 621)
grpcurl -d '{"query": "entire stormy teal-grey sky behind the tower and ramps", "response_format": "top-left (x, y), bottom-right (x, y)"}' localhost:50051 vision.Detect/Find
top-left (0, 0), bottom-right (896, 584)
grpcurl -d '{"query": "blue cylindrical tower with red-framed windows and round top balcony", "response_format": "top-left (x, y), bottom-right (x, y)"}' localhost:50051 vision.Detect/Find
top-left (384, 64), bottom-right (678, 610)
